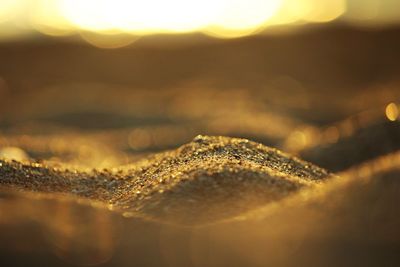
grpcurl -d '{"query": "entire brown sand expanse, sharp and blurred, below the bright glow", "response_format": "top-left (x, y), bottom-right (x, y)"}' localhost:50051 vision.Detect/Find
top-left (0, 25), bottom-right (400, 267)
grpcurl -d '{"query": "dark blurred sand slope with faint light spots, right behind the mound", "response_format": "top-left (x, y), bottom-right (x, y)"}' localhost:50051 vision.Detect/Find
top-left (299, 107), bottom-right (400, 172)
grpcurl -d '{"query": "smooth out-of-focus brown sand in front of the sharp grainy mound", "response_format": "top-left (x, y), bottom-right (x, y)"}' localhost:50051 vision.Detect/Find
top-left (0, 146), bottom-right (400, 267)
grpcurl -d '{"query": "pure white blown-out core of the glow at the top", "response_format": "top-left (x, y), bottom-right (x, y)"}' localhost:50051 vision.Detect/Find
top-left (59, 0), bottom-right (281, 34)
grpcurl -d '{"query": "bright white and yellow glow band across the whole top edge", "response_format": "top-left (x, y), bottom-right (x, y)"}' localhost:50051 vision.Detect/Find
top-left (0, 0), bottom-right (400, 43)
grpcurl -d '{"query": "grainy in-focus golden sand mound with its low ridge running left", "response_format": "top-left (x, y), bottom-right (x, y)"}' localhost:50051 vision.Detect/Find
top-left (0, 136), bottom-right (330, 224)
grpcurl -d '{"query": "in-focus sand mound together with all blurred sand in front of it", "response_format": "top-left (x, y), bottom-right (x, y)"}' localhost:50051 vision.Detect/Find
top-left (0, 136), bottom-right (400, 267)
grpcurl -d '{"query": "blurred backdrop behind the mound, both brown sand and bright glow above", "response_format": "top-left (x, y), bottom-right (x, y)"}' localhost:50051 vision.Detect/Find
top-left (0, 0), bottom-right (400, 164)
